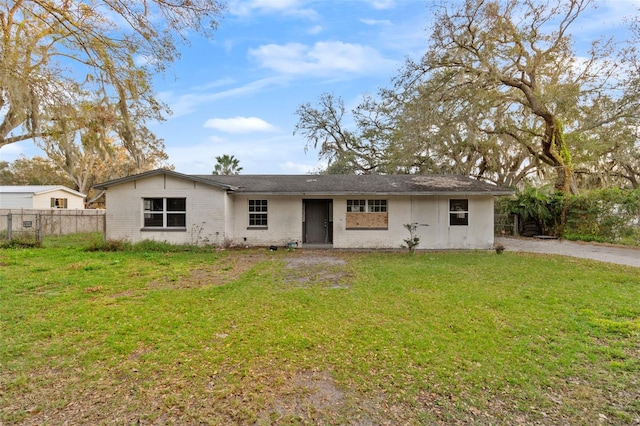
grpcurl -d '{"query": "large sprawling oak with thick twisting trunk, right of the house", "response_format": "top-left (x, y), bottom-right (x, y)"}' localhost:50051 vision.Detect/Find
top-left (399, 0), bottom-right (638, 193)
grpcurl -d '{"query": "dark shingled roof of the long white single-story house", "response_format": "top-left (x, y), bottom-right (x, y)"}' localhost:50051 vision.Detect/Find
top-left (96, 170), bottom-right (513, 195)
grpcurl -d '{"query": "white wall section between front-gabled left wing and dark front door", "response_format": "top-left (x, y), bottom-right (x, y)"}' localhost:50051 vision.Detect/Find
top-left (228, 195), bottom-right (302, 246)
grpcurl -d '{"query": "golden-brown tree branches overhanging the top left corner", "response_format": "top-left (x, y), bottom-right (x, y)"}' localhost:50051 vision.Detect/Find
top-left (0, 0), bottom-right (223, 150)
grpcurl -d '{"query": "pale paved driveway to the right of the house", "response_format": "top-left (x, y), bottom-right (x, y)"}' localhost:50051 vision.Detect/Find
top-left (495, 237), bottom-right (640, 268)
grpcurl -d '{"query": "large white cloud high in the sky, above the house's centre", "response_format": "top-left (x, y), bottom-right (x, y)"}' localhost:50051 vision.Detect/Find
top-left (249, 41), bottom-right (397, 76)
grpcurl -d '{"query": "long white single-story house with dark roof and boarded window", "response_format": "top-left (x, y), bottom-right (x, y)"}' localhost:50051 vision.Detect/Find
top-left (96, 170), bottom-right (513, 249)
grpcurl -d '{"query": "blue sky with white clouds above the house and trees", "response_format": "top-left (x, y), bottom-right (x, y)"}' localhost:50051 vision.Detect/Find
top-left (0, 0), bottom-right (640, 174)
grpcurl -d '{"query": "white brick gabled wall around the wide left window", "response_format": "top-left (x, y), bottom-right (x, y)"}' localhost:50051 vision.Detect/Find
top-left (106, 175), bottom-right (228, 245)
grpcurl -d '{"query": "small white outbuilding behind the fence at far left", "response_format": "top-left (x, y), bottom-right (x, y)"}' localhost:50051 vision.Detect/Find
top-left (0, 185), bottom-right (86, 210)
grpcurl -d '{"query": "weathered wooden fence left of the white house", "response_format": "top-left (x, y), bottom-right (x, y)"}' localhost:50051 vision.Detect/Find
top-left (0, 209), bottom-right (105, 241)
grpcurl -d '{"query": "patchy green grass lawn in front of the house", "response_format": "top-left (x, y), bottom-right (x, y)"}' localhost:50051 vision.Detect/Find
top-left (0, 235), bottom-right (640, 425)
